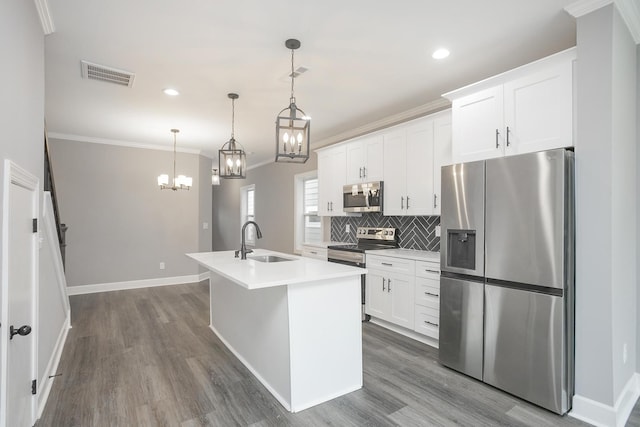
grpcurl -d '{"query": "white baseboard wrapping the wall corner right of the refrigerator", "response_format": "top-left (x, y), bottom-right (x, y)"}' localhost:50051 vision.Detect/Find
top-left (569, 373), bottom-right (640, 427)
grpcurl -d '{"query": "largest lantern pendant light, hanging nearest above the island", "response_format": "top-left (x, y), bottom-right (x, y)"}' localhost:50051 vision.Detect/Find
top-left (276, 39), bottom-right (311, 163)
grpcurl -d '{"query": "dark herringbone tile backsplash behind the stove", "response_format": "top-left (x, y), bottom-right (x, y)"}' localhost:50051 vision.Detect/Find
top-left (331, 213), bottom-right (440, 252)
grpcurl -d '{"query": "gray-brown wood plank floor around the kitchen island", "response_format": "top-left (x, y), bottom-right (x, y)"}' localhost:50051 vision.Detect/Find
top-left (36, 283), bottom-right (640, 427)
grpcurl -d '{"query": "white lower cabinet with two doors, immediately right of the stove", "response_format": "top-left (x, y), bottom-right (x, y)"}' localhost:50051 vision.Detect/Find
top-left (365, 255), bottom-right (415, 329)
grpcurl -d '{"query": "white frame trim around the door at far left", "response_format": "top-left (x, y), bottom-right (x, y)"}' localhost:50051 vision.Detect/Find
top-left (0, 159), bottom-right (40, 427)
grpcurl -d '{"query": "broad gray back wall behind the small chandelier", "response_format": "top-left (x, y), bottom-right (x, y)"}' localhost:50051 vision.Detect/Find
top-left (50, 140), bottom-right (211, 286)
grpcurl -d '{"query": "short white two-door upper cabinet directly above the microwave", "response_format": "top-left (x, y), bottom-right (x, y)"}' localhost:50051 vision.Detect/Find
top-left (345, 135), bottom-right (383, 184)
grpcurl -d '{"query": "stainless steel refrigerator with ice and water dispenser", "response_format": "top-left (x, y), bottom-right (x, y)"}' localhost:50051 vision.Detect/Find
top-left (439, 149), bottom-right (575, 414)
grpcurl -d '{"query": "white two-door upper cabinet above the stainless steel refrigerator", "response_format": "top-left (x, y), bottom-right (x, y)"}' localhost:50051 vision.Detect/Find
top-left (444, 49), bottom-right (576, 163)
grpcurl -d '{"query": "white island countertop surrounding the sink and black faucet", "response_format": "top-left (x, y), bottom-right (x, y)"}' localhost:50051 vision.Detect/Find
top-left (186, 249), bottom-right (367, 289)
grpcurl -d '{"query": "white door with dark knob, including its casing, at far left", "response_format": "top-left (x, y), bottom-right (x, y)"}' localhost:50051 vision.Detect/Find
top-left (0, 161), bottom-right (38, 427)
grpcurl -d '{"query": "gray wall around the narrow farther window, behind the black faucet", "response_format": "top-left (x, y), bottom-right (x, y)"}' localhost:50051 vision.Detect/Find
top-left (213, 157), bottom-right (318, 253)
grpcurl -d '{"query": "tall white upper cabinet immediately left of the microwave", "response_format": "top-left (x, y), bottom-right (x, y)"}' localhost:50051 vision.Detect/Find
top-left (318, 145), bottom-right (346, 216)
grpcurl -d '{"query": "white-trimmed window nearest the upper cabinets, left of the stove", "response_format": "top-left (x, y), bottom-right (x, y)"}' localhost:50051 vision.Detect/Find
top-left (294, 171), bottom-right (323, 251)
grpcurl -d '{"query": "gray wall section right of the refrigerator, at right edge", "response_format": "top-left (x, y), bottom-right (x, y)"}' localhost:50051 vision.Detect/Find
top-left (576, 5), bottom-right (637, 406)
